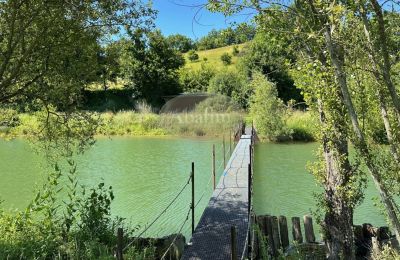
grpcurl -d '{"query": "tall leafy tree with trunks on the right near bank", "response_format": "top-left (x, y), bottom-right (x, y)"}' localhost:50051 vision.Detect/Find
top-left (209, 0), bottom-right (399, 259)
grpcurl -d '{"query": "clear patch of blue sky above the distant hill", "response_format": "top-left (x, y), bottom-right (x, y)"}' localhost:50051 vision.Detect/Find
top-left (153, 0), bottom-right (255, 39)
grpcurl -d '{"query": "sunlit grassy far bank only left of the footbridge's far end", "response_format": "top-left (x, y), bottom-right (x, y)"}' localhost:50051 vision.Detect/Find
top-left (0, 111), bottom-right (242, 137)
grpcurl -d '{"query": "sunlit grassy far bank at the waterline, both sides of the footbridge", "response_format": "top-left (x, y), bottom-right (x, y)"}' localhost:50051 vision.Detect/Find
top-left (0, 111), bottom-right (317, 142)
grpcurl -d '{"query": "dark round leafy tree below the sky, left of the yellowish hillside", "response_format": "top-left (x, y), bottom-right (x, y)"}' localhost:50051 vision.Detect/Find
top-left (120, 30), bottom-right (185, 106)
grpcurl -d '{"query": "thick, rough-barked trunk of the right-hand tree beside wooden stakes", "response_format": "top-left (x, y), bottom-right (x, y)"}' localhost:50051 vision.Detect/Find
top-left (318, 100), bottom-right (355, 259)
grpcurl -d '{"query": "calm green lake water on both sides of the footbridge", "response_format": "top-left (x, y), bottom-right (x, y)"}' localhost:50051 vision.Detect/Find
top-left (0, 137), bottom-right (385, 240)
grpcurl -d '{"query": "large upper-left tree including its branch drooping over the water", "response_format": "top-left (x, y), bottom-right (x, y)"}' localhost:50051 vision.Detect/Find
top-left (0, 0), bottom-right (154, 154)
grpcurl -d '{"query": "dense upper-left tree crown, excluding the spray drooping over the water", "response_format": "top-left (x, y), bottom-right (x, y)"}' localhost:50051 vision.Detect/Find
top-left (0, 0), bottom-right (153, 108)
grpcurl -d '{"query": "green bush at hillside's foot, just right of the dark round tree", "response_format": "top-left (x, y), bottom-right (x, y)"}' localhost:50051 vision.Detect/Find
top-left (179, 63), bottom-right (215, 93)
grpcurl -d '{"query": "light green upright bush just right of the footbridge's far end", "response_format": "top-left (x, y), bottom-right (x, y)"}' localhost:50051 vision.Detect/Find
top-left (250, 72), bottom-right (289, 141)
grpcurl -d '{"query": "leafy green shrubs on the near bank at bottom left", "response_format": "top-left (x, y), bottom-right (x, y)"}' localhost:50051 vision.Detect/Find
top-left (0, 160), bottom-right (142, 259)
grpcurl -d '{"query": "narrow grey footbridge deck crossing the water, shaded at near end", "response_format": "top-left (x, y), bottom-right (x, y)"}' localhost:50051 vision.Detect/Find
top-left (182, 129), bottom-right (252, 260)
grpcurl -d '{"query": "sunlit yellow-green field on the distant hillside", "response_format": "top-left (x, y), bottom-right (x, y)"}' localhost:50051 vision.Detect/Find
top-left (185, 43), bottom-right (246, 69)
